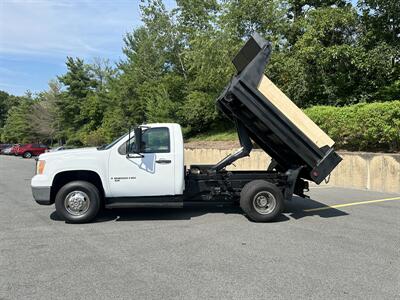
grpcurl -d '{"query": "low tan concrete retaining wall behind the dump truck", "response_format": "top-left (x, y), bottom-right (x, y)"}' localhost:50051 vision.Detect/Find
top-left (185, 149), bottom-right (400, 193)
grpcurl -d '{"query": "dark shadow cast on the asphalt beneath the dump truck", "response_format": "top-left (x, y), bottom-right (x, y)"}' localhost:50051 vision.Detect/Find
top-left (50, 196), bottom-right (348, 223)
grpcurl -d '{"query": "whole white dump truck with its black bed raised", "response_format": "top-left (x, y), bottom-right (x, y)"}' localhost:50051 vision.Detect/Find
top-left (31, 34), bottom-right (341, 223)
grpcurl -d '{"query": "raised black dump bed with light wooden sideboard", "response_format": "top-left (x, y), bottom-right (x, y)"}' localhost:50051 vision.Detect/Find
top-left (217, 34), bottom-right (342, 183)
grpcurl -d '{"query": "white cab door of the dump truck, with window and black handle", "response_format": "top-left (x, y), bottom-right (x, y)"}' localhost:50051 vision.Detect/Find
top-left (109, 127), bottom-right (175, 197)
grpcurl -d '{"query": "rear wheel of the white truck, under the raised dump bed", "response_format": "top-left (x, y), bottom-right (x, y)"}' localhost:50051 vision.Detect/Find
top-left (240, 180), bottom-right (285, 222)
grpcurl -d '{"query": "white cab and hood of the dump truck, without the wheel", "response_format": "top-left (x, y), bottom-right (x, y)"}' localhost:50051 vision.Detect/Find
top-left (31, 123), bottom-right (185, 204)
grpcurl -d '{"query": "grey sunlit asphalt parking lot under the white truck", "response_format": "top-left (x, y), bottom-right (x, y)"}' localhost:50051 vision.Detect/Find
top-left (0, 156), bottom-right (400, 299)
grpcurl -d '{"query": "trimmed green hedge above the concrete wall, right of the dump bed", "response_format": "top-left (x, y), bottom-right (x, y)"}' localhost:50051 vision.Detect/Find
top-left (305, 101), bottom-right (400, 152)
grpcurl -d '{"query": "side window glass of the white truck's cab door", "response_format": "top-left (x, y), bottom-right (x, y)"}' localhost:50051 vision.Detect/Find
top-left (118, 127), bottom-right (170, 155)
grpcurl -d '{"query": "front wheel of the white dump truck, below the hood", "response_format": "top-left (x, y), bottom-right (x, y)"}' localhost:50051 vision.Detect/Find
top-left (55, 181), bottom-right (101, 223)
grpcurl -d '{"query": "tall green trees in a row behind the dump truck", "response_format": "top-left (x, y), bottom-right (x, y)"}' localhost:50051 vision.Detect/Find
top-left (0, 0), bottom-right (400, 145)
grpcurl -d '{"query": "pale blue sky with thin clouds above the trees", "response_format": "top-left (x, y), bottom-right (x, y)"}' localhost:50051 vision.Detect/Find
top-left (0, 0), bottom-right (174, 95)
